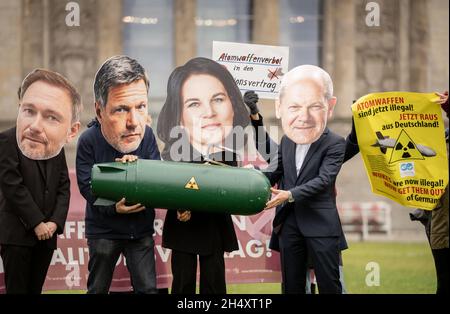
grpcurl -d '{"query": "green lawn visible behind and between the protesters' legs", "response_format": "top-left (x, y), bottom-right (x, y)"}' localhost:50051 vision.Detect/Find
top-left (46, 242), bottom-right (436, 294)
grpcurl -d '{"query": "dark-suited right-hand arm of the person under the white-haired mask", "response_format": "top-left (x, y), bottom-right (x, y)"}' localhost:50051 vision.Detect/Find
top-left (290, 139), bottom-right (345, 202)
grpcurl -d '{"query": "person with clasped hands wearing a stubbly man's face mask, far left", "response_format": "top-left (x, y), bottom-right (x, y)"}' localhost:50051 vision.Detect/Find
top-left (0, 69), bottom-right (82, 294)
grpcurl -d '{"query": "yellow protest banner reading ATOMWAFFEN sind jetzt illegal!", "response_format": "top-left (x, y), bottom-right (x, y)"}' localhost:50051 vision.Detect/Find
top-left (352, 92), bottom-right (448, 210)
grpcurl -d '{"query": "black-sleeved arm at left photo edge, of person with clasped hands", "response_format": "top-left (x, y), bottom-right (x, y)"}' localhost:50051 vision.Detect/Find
top-left (0, 134), bottom-right (45, 230)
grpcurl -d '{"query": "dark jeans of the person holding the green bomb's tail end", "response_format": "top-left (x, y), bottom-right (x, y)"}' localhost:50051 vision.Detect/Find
top-left (87, 236), bottom-right (157, 294)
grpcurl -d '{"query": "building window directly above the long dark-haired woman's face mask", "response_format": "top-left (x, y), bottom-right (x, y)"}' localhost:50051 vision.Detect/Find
top-left (195, 0), bottom-right (252, 58)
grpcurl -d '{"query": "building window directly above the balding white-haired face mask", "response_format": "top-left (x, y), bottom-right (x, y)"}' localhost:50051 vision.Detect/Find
top-left (279, 0), bottom-right (323, 69)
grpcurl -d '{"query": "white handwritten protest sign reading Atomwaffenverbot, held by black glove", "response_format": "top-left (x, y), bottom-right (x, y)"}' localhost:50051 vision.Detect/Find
top-left (212, 41), bottom-right (289, 99)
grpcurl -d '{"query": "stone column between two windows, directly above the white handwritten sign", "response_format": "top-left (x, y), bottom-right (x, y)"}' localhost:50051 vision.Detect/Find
top-left (253, 0), bottom-right (280, 45)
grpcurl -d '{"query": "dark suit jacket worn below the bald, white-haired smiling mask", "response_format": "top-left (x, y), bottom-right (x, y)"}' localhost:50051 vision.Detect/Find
top-left (266, 128), bottom-right (345, 248)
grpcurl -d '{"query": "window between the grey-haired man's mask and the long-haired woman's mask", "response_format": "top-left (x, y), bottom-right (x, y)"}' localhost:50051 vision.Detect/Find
top-left (122, 0), bottom-right (175, 103)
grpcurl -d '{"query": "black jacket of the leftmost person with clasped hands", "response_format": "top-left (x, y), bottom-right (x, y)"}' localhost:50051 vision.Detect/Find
top-left (0, 128), bottom-right (70, 248)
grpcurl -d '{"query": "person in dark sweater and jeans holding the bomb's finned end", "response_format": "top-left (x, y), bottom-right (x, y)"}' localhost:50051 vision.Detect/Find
top-left (76, 55), bottom-right (160, 294)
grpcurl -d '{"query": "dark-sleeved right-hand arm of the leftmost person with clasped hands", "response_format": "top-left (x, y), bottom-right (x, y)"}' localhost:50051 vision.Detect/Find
top-left (49, 149), bottom-right (70, 234)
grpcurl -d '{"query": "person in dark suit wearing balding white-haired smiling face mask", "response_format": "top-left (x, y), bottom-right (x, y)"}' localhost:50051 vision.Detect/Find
top-left (267, 65), bottom-right (345, 293)
